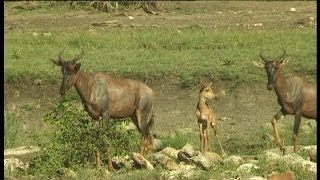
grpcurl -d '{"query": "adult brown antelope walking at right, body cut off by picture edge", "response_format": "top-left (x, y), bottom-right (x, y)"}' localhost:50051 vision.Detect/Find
top-left (253, 49), bottom-right (317, 154)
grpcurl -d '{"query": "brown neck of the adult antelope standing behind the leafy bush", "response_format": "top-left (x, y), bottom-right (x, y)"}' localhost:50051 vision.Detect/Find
top-left (74, 70), bottom-right (94, 104)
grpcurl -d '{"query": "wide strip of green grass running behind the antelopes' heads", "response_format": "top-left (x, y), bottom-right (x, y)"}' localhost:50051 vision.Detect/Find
top-left (5, 27), bottom-right (316, 86)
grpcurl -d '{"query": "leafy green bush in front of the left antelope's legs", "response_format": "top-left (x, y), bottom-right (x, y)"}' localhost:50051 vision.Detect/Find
top-left (31, 101), bottom-right (140, 175)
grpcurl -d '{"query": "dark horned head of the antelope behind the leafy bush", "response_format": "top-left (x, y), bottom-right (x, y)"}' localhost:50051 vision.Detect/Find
top-left (50, 49), bottom-right (84, 96)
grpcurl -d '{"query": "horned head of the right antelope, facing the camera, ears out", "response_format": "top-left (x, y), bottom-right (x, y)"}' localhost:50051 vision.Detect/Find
top-left (253, 49), bottom-right (289, 90)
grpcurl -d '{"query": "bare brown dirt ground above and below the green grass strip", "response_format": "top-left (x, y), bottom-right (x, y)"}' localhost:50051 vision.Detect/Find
top-left (5, 1), bottom-right (316, 149)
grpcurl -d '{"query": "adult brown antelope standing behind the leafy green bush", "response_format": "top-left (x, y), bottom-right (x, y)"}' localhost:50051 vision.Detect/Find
top-left (51, 50), bottom-right (154, 170)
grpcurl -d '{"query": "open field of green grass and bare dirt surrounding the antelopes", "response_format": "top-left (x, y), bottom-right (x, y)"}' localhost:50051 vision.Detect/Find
top-left (4, 1), bottom-right (316, 179)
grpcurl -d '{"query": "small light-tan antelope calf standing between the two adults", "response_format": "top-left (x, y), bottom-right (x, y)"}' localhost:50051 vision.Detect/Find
top-left (196, 82), bottom-right (225, 155)
